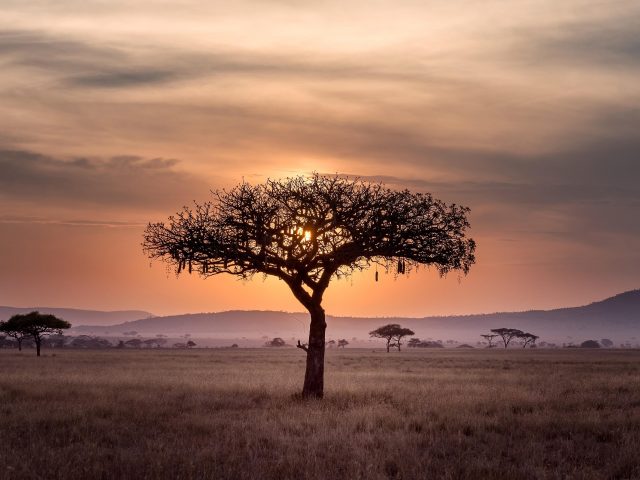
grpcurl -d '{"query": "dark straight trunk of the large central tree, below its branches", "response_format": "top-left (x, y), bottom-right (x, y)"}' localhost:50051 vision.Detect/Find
top-left (302, 305), bottom-right (327, 398)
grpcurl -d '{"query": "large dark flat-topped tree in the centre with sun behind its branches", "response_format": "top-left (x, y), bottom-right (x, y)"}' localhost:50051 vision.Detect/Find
top-left (143, 174), bottom-right (475, 398)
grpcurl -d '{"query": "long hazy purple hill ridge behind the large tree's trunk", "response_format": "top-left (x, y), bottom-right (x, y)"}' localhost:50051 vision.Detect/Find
top-left (76, 290), bottom-right (640, 344)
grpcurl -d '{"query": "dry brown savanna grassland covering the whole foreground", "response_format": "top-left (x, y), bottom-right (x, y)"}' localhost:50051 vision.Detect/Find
top-left (0, 348), bottom-right (640, 480)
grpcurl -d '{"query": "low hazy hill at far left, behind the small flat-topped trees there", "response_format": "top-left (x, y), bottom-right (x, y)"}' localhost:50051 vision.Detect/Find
top-left (0, 306), bottom-right (153, 326)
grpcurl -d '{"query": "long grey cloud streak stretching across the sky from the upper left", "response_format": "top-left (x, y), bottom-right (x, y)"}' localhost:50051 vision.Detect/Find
top-left (0, 31), bottom-right (460, 88)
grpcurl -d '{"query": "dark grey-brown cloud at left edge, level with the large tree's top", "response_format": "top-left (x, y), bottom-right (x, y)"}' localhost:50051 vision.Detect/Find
top-left (0, 150), bottom-right (209, 211)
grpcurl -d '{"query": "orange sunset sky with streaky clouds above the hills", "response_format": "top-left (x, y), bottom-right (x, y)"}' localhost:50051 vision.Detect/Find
top-left (0, 0), bottom-right (640, 316)
